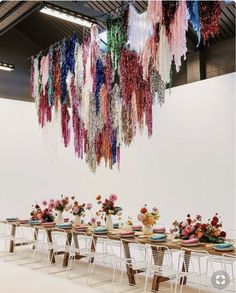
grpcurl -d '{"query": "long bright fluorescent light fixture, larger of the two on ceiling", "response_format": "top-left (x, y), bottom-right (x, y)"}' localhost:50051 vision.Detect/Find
top-left (40, 6), bottom-right (92, 28)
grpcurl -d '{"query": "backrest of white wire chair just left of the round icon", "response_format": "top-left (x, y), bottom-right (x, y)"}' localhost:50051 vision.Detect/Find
top-left (181, 248), bottom-right (209, 275)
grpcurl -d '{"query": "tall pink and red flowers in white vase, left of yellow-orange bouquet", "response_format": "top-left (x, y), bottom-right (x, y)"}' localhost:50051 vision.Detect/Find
top-left (96, 194), bottom-right (122, 231)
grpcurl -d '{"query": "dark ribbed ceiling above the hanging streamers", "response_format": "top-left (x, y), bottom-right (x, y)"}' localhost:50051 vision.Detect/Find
top-left (0, 1), bottom-right (235, 52)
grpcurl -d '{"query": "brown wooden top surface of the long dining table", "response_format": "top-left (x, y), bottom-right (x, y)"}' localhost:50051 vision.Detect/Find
top-left (0, 221), bottom-right (236, 256)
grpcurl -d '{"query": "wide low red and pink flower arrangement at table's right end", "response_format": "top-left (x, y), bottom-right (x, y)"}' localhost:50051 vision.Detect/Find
top-left (170, 213), bottom-right (226, 243)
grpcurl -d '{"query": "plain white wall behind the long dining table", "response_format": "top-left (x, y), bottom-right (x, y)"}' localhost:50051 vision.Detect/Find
top-left (0, 74), bottom-right (235, 229)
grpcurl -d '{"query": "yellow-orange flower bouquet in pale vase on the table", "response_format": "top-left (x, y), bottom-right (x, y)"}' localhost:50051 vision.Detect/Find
top-left (138, 204), bottom-right (160, 235)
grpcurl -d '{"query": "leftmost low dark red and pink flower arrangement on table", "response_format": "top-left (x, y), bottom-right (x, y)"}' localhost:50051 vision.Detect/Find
top-left (30, 201), bottom-right (54, 222)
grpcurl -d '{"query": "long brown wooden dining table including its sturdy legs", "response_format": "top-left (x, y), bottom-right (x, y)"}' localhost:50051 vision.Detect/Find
top-left (0, 221), bottom-right (235, 291)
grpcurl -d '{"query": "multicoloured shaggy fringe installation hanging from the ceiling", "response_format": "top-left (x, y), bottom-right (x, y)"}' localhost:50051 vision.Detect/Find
top-left (31, 0), bottom-right (220, 172)
